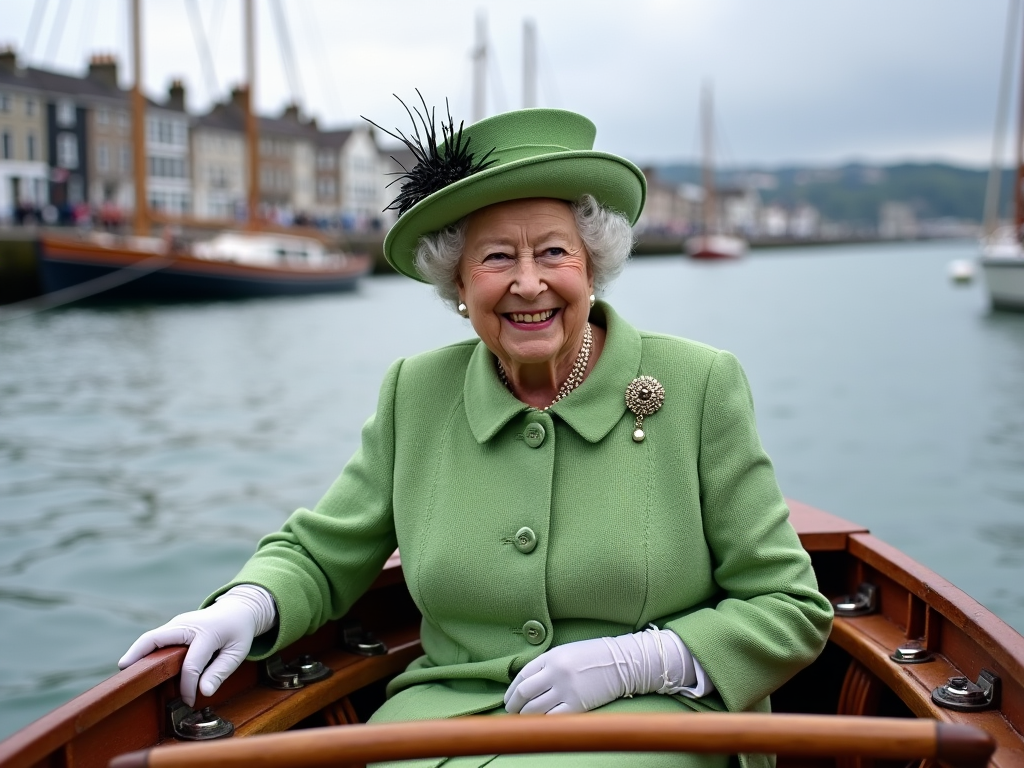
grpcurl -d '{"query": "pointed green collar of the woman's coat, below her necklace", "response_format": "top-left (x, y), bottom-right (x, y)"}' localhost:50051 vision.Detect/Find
top-left (463, 301), bottom-right (640, 443)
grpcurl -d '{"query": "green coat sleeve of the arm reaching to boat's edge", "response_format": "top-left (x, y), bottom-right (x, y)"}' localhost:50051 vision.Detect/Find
top-left (203, 360), bottom-right (401, 658)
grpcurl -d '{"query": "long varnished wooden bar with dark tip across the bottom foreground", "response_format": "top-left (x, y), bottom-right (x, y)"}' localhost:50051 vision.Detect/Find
top-left (103, 713), bottom-right (995, 768)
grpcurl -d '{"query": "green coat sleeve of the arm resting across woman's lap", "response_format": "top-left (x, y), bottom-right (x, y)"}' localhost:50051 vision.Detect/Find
top-left (666, 352), bottom-right (833, 712)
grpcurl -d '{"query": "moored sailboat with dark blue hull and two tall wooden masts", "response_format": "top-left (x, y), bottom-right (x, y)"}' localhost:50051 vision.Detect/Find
top-left (37, 0), bottom-right (373, 303)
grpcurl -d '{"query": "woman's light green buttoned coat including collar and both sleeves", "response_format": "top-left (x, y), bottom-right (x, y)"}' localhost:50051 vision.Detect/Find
top-left (207, 303), bottom-right (831, 765)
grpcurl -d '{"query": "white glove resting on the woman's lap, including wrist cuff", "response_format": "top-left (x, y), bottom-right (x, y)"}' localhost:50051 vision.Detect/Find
top-left (505, 628), bottom-right (714, 715)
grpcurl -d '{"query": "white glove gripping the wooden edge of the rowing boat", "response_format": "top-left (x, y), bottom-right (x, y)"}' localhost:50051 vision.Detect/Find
top-left (118, 584), bottom-right (278, 707)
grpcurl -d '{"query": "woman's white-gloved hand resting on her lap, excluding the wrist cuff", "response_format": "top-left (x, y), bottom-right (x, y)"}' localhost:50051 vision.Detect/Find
top-left (505, 637), bottom-right (632, 715)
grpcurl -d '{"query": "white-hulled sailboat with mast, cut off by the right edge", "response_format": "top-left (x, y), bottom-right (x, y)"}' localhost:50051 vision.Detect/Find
top-left (979, 0), bottom-right (1024, 311)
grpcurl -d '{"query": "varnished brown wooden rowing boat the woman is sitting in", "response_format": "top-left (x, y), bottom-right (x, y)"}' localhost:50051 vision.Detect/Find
top-left (0, 502), bottom-right (1024, 768)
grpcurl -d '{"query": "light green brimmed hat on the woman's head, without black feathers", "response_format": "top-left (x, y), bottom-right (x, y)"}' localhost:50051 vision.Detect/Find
top-left (384, 110), bottom-right (647, 282)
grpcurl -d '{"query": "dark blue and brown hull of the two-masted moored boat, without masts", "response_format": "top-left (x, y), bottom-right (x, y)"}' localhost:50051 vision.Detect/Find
top-left (37, 232), bottom-right (373, 300)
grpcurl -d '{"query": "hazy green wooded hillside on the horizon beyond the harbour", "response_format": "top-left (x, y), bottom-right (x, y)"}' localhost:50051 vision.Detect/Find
top-left (656, 163), bottom-right (1013, 225)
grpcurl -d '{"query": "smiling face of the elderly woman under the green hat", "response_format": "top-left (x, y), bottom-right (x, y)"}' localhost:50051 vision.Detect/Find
top-left (456, 199), bottom-right (594, 386)
